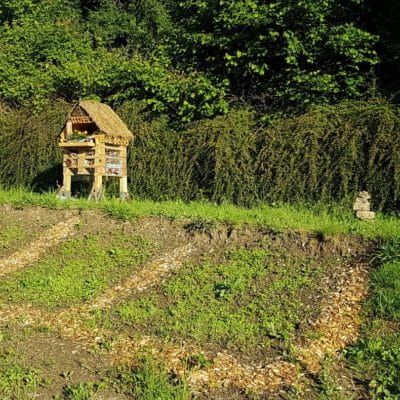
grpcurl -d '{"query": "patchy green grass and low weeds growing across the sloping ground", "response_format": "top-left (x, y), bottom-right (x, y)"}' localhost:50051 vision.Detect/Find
top-left (0, 190), bottom-right (400, 400)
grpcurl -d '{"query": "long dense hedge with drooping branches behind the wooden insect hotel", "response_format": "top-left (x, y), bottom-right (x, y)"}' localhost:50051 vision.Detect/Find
top-left (0, 100), bottom-right (400, 210)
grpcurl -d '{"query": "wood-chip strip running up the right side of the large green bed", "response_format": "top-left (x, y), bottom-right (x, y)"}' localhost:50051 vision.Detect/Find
top-left (296, 263), bottom-right (368, 374)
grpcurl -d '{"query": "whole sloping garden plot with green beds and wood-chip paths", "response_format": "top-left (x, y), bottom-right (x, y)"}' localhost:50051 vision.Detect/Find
top-left (0, 192), bottom-right (399, 399)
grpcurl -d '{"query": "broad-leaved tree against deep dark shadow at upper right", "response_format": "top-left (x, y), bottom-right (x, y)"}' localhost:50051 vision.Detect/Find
top-left (176, 0), bottom-right (378, 109)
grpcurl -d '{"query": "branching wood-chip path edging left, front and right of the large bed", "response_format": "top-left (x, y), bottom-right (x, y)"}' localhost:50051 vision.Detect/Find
top-left (0, 256), bottom-right (368, 391)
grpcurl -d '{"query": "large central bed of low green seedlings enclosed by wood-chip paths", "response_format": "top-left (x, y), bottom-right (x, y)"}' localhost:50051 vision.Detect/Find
top-left (87, 249), bottom-right (331, 354)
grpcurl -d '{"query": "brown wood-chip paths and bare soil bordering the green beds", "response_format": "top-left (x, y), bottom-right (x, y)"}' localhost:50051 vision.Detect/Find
top-left (0, 205), bottom-right (368, 398)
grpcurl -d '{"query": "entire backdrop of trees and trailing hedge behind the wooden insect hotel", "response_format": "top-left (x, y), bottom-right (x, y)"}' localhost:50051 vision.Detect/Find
top-left (0, 0), bottom-right (400, 210)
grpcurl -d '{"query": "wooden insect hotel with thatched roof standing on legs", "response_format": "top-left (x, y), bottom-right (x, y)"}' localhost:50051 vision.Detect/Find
top-left (59, 100), bottom-right (133, 200)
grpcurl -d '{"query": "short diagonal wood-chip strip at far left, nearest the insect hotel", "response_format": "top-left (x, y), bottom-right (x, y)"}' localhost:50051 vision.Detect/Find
top-left (0, 216), bottom-right (79, 276)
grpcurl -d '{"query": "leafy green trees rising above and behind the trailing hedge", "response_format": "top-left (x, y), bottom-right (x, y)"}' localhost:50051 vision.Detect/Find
top-left (0, 0), bottom-right (400, 115)
